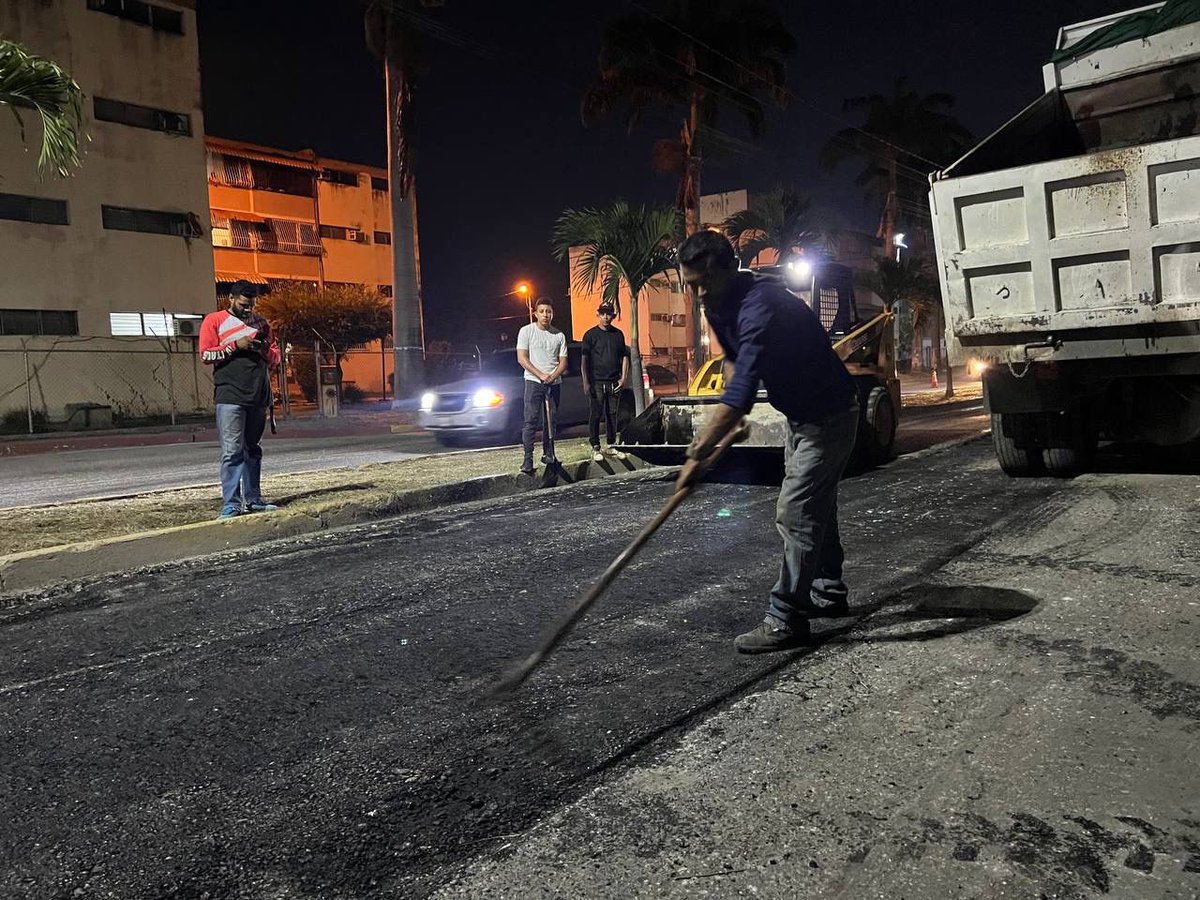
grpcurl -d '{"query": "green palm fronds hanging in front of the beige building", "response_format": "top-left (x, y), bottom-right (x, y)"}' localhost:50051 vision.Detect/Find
top-left (0, 41), bottom-right (85, 178)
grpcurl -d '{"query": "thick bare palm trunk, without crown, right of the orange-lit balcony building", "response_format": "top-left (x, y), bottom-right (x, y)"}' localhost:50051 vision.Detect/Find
top-left (384, 41), bottom-right (425, 408)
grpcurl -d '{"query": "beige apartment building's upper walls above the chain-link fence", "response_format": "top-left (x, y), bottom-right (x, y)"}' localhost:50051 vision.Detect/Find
top-left (0, 0), bottom-right (212, 337)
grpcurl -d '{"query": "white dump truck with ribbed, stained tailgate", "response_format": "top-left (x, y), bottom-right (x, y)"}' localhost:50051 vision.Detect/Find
top-left (930, 0), bottom-right (1200, 476)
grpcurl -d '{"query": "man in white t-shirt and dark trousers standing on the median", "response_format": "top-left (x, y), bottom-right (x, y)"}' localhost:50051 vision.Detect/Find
top-left (517, 298), bottom-right (566, 475)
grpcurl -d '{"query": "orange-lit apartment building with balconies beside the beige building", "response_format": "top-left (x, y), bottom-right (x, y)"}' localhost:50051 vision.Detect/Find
top-left (204, 137), bottom-right (394, 396)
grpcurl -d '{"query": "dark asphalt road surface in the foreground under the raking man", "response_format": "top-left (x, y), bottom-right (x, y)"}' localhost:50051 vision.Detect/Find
top-left (0, 440), bottom-right (1200, 898)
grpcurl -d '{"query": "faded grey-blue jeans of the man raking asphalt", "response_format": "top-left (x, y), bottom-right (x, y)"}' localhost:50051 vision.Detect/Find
top-left (767, 402), bottom-right (858, 625)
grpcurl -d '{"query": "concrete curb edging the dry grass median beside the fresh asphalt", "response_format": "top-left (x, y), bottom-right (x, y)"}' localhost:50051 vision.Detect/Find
top-left (0, 456), bottom-right (648, 594)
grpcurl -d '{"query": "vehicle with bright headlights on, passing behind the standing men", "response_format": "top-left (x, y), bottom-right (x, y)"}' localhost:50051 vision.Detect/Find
top-left (418, 343), bottom-right (634, 446)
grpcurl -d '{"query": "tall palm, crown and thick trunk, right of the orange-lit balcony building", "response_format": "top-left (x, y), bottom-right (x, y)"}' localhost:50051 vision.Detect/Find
top-left (364, 0), bottom-right (440, 403)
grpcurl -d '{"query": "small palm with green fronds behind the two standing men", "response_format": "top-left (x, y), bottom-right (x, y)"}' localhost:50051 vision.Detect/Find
top-left (551, 200), bottom-right (682, 414)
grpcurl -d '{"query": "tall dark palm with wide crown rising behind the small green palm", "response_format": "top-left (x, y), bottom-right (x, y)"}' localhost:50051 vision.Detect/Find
top-left (581, 0), bottom-right (796, 372)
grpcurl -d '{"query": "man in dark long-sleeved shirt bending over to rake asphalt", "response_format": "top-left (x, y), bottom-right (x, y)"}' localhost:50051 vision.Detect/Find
top-left (677, 232), bottom-right (858, 653)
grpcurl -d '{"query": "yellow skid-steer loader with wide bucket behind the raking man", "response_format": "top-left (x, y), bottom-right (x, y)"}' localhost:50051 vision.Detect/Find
top-left (620, 260), bottom-right (900, 472)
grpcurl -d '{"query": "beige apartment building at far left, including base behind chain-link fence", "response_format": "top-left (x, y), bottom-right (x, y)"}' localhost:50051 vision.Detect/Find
top-left (0, 0), bottom-right (212, 427)
